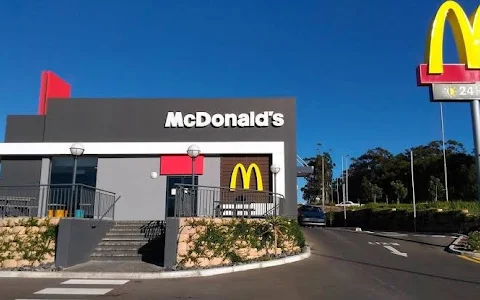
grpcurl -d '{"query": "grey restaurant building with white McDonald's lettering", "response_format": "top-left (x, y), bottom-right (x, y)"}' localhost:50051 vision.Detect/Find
top-left (0, 91), bottom-right (296, 220)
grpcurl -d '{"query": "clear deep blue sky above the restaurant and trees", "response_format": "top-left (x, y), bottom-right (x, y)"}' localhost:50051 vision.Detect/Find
top-left (0, 0), bottom-right (480, 202)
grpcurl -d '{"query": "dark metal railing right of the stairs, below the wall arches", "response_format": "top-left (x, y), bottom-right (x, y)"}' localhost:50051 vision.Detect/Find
top-left (174, 184), bottom-right (284, 218)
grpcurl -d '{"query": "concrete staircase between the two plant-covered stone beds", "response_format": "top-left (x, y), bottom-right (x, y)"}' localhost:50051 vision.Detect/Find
top-left (90, 221), bottom-right (165, 263)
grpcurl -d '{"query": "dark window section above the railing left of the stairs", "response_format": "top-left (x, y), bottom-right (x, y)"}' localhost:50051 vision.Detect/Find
top-left (50, 156), bottom-right (98, 187)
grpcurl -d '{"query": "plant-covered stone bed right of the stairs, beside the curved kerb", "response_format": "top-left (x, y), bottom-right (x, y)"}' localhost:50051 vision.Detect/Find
top-left (177, 217), bottom-right (305, 267)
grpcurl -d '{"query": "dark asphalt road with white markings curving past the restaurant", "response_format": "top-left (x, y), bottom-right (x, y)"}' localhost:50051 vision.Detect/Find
top-left (0, 228), bottom-right (480, 300)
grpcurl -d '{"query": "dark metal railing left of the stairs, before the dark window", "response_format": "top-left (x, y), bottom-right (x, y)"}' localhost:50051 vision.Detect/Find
top-left (0, 184), bottom-right (115, 219)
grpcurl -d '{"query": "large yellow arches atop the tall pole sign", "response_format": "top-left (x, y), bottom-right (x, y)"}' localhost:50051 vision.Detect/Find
top-left (425, 0), bottom-right (480, 74)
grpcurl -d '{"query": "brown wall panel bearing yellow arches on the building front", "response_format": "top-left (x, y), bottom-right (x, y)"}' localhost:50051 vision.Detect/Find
top-left (220, 156), bottom-right (271, 191)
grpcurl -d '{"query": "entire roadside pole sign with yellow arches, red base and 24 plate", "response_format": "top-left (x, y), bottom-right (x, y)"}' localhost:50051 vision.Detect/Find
top-left (417, 0), bottom-right (480, 201)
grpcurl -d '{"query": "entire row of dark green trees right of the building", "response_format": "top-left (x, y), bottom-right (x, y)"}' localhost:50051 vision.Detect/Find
top-left (302, 140), bottom-right (477, 203)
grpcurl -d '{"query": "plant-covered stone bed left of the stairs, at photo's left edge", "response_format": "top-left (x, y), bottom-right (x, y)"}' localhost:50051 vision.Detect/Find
top-left (0, 218), bottom-right (59, 268)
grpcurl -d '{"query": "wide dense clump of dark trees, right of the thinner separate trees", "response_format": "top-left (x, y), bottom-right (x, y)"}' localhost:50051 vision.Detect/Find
top-left (342, 140), bottom-right (477, 202)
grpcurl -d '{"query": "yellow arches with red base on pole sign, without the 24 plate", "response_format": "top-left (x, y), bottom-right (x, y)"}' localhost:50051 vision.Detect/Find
top-left (417, 1), bottom-right (480, 86)
